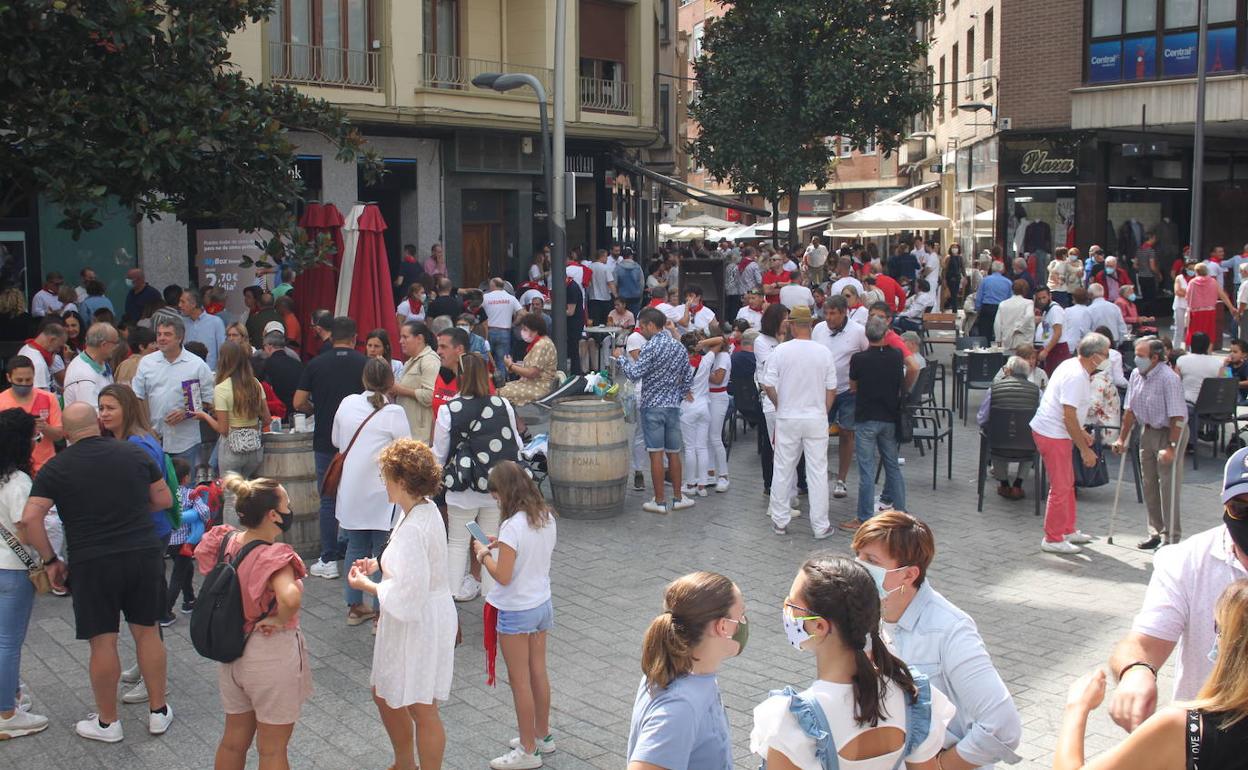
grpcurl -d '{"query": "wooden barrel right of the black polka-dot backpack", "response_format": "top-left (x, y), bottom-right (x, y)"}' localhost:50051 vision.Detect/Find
top-left (547, 398), bottom-right (633, 519)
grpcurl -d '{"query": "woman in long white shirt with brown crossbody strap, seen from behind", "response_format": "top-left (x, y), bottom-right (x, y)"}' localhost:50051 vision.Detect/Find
top-left (331, 358), bottom-right (412, 625)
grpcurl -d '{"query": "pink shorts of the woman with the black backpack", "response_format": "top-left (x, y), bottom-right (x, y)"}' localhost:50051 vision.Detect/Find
top-left (217, 629), bottom-right (312, 725)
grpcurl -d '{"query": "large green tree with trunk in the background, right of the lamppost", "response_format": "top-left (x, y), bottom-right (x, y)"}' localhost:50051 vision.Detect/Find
top-left (690, 0), bottom-right (936, 242)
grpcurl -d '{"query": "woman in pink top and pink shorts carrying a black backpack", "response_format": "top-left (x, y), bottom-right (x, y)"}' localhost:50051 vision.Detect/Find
top-left (195, 473), bottom-right (312, 770)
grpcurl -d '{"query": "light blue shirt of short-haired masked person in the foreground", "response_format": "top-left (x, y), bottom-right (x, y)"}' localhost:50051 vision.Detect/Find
top-left (885, 580), bottom-right (1022, 766)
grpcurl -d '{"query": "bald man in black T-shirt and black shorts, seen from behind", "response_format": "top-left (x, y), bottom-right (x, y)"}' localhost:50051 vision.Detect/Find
top-left (17, 402), bottom-right (173, 743)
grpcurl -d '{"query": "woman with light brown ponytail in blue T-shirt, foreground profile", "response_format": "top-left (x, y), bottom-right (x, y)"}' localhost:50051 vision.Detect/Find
top-left (628, 572), bottom-right (750, 770)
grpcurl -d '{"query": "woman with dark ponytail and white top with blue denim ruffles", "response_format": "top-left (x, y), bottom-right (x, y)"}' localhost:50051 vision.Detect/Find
top-left (750, 555), bottom-right (955, 770)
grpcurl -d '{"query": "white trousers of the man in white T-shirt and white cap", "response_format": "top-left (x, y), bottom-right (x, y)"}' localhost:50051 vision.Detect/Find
top-left (768, 417), bottom-right (829, 534)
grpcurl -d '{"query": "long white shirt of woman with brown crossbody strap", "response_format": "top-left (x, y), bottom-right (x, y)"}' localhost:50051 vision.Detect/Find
top-left (331, 391), bottom-right (411, 532)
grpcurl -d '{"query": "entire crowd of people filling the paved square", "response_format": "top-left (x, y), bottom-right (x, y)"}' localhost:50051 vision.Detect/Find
top-left (0, 238), bottom-right (1248, 770)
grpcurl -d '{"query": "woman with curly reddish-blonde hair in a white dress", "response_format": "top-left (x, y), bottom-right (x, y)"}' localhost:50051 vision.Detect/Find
top-left (347, 438), bottom-right (458, 770)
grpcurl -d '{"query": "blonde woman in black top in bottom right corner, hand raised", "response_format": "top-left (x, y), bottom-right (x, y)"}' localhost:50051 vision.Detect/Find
top-left (1053, 580), bottom-right (1248, 770)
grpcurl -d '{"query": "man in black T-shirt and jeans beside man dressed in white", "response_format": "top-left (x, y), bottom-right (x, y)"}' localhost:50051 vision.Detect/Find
top-left (841, 317), bottom-right (906, 530)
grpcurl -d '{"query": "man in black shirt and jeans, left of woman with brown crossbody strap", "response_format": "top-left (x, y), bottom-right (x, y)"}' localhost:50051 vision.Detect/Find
top-left (292, 316), bottom-right (368, 579)
